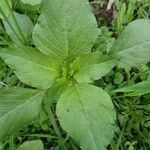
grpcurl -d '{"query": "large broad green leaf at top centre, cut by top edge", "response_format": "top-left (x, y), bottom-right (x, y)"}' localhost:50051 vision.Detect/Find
top-left (33, 0), bottom-right (98, 59)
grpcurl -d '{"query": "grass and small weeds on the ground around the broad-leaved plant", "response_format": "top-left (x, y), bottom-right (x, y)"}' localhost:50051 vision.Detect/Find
top-left (0, 0), bottom-right (150, 150)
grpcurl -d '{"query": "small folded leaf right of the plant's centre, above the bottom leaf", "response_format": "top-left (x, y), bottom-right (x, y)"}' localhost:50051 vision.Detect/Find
top-left (73, 52), bottom-right (115, 83)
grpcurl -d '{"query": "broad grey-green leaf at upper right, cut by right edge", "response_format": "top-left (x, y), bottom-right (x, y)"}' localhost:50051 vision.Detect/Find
top-left (111, 19), bottom-right (150, 67)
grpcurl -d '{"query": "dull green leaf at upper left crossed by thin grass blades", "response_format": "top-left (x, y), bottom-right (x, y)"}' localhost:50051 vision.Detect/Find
top-left (3, 12), bottom-right (33, 44)
